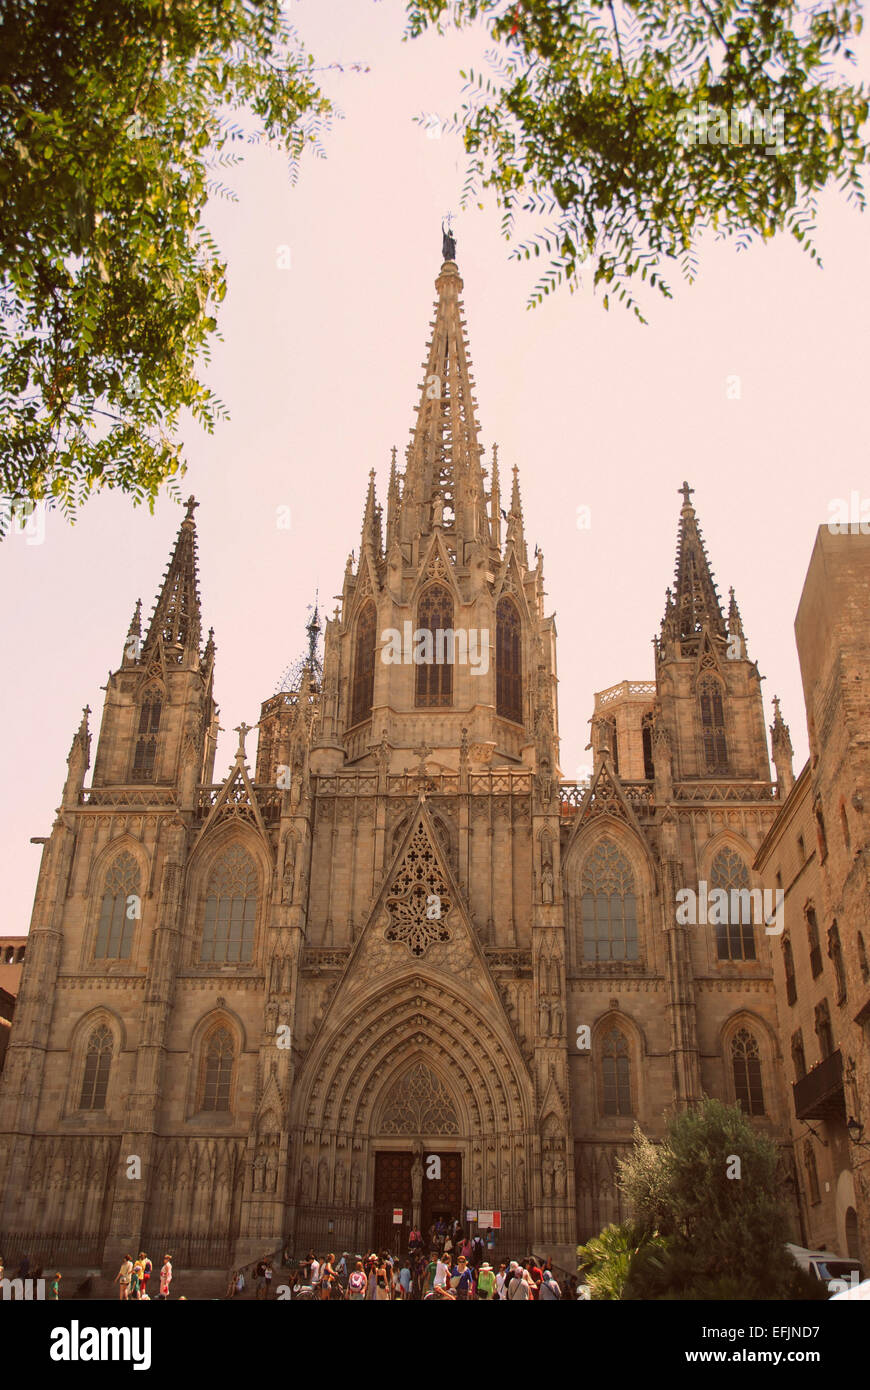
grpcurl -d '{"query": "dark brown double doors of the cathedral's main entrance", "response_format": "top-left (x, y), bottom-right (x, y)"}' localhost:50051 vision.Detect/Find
top-left (371, 1150), bottom-right (466, 1255)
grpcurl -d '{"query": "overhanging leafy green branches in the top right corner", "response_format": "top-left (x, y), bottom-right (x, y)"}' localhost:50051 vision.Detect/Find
top-left (407, 0), bottom-right (867, 318)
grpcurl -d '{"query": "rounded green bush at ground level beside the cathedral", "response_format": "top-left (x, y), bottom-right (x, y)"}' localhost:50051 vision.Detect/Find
top-left (618, 1099), bottom-right (796, 1298)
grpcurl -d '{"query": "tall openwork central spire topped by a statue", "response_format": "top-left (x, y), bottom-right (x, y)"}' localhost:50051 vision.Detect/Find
top-left (399, 244), bottom-right (491, 545)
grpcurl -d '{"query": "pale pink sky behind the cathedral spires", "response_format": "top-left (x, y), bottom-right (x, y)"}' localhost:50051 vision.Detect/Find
top-left (0, 0), bottom-right (870, 933)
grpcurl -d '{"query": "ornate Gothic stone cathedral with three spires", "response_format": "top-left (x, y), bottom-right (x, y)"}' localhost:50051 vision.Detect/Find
top-left (0, 252), bottom-right (794, 1268)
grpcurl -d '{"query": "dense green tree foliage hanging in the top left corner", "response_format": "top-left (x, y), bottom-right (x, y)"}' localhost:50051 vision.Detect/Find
top-left (0, 0), bottom-right (331, 524)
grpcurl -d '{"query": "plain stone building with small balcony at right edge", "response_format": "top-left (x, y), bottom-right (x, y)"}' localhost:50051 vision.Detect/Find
top-left (757, 527), bottom-right (870, 1261)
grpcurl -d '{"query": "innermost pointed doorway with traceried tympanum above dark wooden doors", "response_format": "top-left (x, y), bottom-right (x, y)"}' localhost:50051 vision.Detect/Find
top-left (372, 1061), bottom-right (464, 1255)
